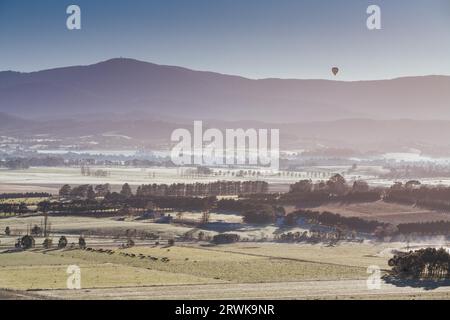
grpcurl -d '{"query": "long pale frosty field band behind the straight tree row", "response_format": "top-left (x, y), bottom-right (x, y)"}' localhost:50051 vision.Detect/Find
top-left (0, 167), bottom-right (341, 192)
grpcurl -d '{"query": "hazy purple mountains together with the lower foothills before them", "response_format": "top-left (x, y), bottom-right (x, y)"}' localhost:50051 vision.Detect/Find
top-left (0, 59), bottom-right (450, 154)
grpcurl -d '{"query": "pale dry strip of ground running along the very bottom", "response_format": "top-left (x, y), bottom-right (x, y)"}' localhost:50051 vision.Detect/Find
top-left (29, 280), bottom-right (450, 300)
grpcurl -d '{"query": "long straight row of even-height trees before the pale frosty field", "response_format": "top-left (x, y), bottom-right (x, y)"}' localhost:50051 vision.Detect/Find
top-left (136, 181), bottom-right (269, 197)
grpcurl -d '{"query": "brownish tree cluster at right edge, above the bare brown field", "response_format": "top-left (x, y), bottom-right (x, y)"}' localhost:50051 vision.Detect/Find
top-left (383, 180), bottom-right (450, 210)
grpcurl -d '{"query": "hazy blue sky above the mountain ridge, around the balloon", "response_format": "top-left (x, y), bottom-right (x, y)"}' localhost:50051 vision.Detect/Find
top-left (0, 0), bottom-right (450, 80)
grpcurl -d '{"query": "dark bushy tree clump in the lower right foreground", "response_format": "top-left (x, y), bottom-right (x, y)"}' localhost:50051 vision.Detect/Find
top-left (389, 248), bottom-right (450, 279)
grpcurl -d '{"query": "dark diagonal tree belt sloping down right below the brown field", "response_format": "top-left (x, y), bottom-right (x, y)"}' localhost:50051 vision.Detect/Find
top-left (285, 210), bottom-right (388, 233)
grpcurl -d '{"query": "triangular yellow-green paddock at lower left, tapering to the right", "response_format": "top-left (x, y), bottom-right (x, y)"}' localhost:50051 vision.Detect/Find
top-left (0, 251), bottom-right (218, 290)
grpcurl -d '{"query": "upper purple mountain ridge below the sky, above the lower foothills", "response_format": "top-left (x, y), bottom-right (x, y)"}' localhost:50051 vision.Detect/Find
top-left (0, 58), bottom-right (450, 123)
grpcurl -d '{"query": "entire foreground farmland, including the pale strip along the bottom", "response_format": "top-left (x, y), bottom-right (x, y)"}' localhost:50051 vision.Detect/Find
top-left (0, 243), bottom-right (450, 299)
